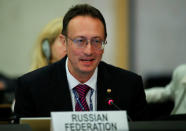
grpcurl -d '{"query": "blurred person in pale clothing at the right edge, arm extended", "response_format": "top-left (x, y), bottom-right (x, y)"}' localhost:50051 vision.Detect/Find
top-left (145, 64), bottom-right (186, 115)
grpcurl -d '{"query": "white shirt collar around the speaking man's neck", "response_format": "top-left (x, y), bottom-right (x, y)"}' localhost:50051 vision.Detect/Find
top-left (66, 57), bottom-right (98, 90)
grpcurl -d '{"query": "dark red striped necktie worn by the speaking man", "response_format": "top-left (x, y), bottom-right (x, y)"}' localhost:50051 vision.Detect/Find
top-left (74, 84), bottom-right (90, 111)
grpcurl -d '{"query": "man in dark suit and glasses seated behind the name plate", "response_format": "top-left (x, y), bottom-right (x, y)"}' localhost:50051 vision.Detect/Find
top-left (15, 4), bottom-right (147, 120)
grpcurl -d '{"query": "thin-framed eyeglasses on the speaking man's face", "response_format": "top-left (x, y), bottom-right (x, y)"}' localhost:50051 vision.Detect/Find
top-left (66, 36), bottom-right (107, 50)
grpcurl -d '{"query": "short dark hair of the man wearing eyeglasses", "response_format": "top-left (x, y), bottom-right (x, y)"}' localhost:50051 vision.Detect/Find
top-left (62, 4), bottom-right (107, 39)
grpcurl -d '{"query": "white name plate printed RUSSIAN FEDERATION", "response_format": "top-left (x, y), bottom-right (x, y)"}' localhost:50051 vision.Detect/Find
top-left (51, 111), bottom-right (128, 131)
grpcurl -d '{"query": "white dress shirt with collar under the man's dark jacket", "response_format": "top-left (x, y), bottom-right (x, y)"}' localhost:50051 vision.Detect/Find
top-left (66, 57), bottom-right (98, 111)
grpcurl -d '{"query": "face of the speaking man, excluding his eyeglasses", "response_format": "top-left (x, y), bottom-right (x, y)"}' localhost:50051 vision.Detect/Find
top-left (66, 16), bottom-right (105, 77)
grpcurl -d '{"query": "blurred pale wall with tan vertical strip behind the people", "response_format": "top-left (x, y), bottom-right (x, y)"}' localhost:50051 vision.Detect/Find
top-left (0, 0), bottom-right (186, 80)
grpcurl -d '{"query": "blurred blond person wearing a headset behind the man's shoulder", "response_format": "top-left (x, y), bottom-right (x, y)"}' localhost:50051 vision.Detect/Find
top-left (30, 17), bottom-right (66, 71)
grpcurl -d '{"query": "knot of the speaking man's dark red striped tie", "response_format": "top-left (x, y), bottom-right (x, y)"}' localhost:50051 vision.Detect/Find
top-left (74, 84), bottom-right (90, 97)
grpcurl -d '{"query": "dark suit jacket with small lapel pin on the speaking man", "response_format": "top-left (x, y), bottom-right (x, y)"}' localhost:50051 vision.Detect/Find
top-left (15, 58), bottom-right (147, 120)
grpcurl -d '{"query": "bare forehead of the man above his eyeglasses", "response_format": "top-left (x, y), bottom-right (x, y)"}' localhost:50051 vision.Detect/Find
top-left (67, 16), bottom-right (104, 38)
